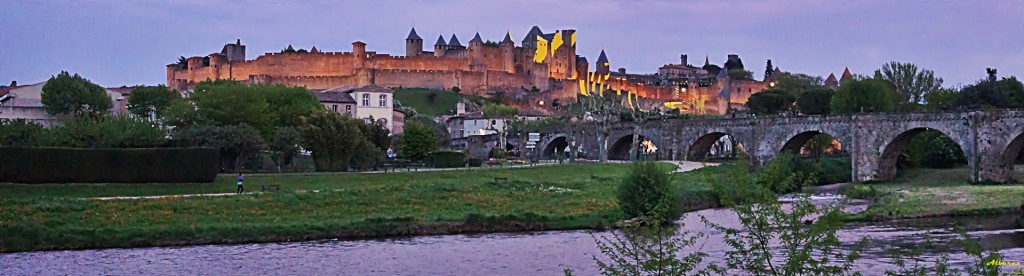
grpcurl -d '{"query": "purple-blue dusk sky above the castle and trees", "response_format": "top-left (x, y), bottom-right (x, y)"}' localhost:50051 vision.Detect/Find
top-left (0, 0), bottom-right (1024, 87)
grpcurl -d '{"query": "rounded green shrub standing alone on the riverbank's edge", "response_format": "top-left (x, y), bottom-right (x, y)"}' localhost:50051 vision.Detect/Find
top-left (616, 162), bottom-right (679, 221)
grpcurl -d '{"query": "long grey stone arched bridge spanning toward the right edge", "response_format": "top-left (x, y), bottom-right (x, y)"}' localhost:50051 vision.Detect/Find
top-left (454, 109), bottom-right (1024, 182)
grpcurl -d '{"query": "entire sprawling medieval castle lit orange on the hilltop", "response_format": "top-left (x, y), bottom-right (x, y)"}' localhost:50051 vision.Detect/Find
top-left (167, 26), bottom-right (769, 113)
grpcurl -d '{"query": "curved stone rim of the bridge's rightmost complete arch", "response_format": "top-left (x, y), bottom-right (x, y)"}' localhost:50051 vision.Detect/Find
top-left (874, 127), bottom-right (974, 181)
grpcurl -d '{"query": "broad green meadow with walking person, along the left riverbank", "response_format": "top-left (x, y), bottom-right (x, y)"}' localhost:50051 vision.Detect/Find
top-left (0, 164), bottom-right (729, 251)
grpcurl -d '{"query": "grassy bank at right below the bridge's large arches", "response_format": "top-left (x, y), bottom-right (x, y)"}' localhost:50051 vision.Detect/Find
top-left (839, 168), bottom-right (1024, 220)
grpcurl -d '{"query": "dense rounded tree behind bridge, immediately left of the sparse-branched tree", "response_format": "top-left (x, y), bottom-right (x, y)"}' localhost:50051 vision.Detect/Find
top-left (831, 79), bottom-right (897, 113)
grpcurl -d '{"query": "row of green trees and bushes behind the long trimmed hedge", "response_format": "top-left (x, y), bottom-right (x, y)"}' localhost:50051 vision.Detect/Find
top-left (0, 72), bottom-right (437, 172)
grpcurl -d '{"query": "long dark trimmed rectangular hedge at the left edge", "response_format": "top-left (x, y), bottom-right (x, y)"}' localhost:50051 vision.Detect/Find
top-left (0, 147), bottom-right (220, 183)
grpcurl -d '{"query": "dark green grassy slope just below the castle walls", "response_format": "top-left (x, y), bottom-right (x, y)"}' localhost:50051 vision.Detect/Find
top-left (394, 88), bottom-right (484, 117)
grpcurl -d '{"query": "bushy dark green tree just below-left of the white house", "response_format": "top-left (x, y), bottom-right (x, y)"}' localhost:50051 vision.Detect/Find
top-left (301, 111), bottom-right (366, 172)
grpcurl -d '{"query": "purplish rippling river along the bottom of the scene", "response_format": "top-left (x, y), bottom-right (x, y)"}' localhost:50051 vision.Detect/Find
top-left (6, 200), bottom-right (1024, 275)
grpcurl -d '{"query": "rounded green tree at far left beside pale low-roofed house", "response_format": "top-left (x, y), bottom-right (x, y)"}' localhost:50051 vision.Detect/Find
top-left (40, 72), bottom-right (114, 120)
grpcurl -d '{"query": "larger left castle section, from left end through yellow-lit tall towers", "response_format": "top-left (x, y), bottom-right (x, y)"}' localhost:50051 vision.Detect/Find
top-left (167, 27), bottom-right (582, 98)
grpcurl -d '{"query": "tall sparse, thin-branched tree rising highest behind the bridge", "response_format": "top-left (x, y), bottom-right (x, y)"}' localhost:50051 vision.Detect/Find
top-left (874, 61), bottom-right (942, 103)
